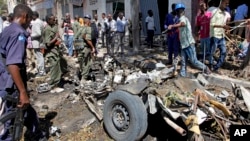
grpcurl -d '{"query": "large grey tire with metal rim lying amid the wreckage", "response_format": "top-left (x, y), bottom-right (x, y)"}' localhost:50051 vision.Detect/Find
top-left (103, 90), bottom-right (148, 141)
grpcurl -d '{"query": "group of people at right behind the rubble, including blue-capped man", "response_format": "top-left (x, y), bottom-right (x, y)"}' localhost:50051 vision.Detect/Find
top-left (161, 0), bottom-right (250, 76)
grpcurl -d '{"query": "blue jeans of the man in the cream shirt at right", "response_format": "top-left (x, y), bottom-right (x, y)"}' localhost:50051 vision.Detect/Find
top-left (209, 37), bottom-right (227, 70)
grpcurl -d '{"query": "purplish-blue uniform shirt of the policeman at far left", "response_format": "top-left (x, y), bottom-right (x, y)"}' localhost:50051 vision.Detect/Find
top-left (0, 23), bottom-right (29, 91)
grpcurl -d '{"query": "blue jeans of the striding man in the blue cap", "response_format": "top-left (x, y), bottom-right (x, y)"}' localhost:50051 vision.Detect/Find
top-left (180, 45), bottom-right (206, 77)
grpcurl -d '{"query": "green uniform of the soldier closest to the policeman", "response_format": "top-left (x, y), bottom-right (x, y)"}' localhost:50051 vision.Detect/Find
top-left (43, 25), bottom-right (67, 87)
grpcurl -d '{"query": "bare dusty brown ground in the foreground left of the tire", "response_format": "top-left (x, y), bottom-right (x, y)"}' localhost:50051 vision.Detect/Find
top-left (26, 41), bottom-right (249, 141)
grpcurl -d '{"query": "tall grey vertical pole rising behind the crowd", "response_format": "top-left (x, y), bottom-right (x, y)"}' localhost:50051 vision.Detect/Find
top-left (130, 0), bottom-right (140, 53)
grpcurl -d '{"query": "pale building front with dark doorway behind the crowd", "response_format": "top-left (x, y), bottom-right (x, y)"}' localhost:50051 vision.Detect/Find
top-left (30, 0), bottom-right (199, 34)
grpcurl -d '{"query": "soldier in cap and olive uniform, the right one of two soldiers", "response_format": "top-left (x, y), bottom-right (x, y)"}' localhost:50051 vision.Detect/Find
top-left (78, 15), bottom-right (95, 87)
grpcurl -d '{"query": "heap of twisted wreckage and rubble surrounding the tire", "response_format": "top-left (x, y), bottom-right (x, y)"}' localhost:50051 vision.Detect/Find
top-left (27, 41), bottom-right (250, 141)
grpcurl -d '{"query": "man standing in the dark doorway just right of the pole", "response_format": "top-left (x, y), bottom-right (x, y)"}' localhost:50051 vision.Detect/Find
top-left (145, 10), bottom-right (156, 48)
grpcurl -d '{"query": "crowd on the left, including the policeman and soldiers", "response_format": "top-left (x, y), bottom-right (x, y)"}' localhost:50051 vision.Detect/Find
top-left (0, 4), bottom-right (127, 141)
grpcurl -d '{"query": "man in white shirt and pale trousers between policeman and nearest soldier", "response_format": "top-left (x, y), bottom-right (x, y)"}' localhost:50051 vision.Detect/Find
top-left (30, 11), bottom-right (45, 77)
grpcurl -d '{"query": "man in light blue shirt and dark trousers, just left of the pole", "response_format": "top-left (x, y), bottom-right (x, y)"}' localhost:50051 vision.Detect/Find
top-left (116, 12), bottom-right (127, 55)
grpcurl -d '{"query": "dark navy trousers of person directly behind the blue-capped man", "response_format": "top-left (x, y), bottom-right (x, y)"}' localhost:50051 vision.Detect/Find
top-left (167, 33), bottom-right (180, 63)
